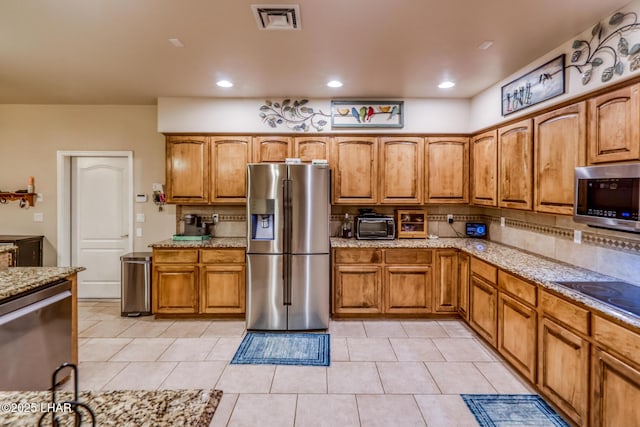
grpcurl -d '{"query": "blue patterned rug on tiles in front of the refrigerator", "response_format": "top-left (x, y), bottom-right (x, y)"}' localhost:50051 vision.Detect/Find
top-left (231, 332), bottom-right (330, 366)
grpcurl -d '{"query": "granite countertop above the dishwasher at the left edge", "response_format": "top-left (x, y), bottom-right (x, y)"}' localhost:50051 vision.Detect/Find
top-left (0, 267), bottom-right (84, 301)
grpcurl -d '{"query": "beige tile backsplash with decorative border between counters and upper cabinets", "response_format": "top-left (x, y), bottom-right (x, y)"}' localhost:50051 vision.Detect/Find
top-left (176, 205), bottom-right (640, 285)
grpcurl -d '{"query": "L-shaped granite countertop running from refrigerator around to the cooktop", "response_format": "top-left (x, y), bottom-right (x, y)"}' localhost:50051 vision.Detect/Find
top-left (331, 237), bottom-right (640, 328)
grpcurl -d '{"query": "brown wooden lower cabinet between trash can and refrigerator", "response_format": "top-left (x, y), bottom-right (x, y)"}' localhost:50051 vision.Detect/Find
top-left (151, 248), bottom-right (245, 317)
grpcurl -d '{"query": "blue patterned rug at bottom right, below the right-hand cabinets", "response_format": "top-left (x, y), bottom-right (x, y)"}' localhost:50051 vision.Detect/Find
top-left (461, 394), bottom-right (569, 427)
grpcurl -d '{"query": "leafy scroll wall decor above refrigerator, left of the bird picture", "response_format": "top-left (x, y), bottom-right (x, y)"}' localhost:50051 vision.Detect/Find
top-left (259, 99), bottom-right (331, 132)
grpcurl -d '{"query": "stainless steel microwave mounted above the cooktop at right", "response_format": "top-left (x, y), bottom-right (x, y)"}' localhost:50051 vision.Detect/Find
top-left (573, 163), bottom-right (640, 233)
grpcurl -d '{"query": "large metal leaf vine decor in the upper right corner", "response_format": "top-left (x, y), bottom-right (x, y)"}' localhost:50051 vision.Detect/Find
top-left (567, 12), bottom-right (640, 85)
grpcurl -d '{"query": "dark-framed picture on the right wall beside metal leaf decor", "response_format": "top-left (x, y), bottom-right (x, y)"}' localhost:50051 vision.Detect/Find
top-left (502, 54), bottom-right (565, 116)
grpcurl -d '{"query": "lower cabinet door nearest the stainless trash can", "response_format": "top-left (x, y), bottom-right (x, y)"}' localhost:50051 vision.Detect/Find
top-left (151, 264), bottom-right (198, 314)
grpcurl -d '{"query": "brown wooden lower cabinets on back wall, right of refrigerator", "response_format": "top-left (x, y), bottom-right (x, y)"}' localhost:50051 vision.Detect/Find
top-left (332, 248), bottom-right (458, 317)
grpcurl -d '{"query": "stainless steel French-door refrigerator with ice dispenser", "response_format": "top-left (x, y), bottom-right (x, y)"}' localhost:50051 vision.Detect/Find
top-left (247, 163), bottom-right (330, 330)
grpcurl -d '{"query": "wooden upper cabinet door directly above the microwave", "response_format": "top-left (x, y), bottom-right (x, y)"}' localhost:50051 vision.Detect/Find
top-left (587, 84), bottom-right (640, 164)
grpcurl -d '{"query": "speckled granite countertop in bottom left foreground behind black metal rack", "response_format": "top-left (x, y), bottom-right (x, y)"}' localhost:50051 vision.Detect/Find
top-left (0, 390), bottom-right (222, 427)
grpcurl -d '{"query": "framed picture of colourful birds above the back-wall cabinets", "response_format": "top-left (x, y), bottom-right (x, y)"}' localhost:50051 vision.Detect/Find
top-left (331, 101), bottom-right (404, 128)
